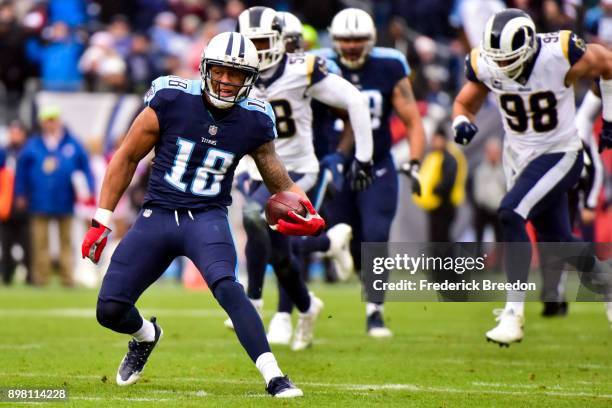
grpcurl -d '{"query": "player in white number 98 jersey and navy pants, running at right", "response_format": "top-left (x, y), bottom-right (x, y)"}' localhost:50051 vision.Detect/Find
top-left (453, 9), bottom-right (612, 345)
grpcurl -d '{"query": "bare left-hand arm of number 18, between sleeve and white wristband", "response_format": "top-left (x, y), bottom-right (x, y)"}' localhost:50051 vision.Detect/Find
top-left (98, 107), bottom-right (159, 211)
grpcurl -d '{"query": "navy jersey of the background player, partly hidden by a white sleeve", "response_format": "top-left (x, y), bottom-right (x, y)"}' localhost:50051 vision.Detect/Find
top-left (313, 47), bottom-right (410, 162)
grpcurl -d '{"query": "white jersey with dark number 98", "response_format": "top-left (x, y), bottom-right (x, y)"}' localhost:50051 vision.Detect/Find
top-left (466, 31), bottom-right (585, 178)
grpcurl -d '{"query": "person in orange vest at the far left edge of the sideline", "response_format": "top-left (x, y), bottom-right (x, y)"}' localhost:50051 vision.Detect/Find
top-left (0, 121), bottom-right (32, 285)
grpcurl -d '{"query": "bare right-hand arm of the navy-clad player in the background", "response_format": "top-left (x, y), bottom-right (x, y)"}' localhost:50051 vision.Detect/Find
top-left (392, 77), bottom-right (425, 160)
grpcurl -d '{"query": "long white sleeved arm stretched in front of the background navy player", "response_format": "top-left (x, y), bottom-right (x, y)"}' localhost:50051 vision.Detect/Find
top-left (309, 74), bottom-right (374, 162)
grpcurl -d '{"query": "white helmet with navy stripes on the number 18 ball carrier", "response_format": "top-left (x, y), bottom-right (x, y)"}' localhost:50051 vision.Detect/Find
top-left (200, 32), bottom-right (259, 109)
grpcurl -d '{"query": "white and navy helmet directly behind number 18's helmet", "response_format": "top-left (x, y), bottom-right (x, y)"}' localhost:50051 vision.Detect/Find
top-left (237, 6), bottom-right (285, 71)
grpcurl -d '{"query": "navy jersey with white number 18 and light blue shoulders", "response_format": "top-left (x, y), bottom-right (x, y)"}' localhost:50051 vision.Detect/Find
top-left (144, 76), bottom-right (276, 210)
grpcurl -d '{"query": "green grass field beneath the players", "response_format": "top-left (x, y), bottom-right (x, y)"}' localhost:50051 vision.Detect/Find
top-left (0, 283), bottom-right (612, 408)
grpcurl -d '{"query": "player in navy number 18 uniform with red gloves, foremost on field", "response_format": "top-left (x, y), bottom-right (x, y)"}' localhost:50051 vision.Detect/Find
top-left (82, 32), bottom-right (325, 397)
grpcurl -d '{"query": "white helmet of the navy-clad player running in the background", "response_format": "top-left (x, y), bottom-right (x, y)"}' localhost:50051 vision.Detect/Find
top-left (329, 8), bottom-right (376, 69)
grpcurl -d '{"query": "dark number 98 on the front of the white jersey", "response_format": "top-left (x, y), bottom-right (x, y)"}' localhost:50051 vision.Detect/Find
top-left (499, 92), bottom-right (559, 133)
